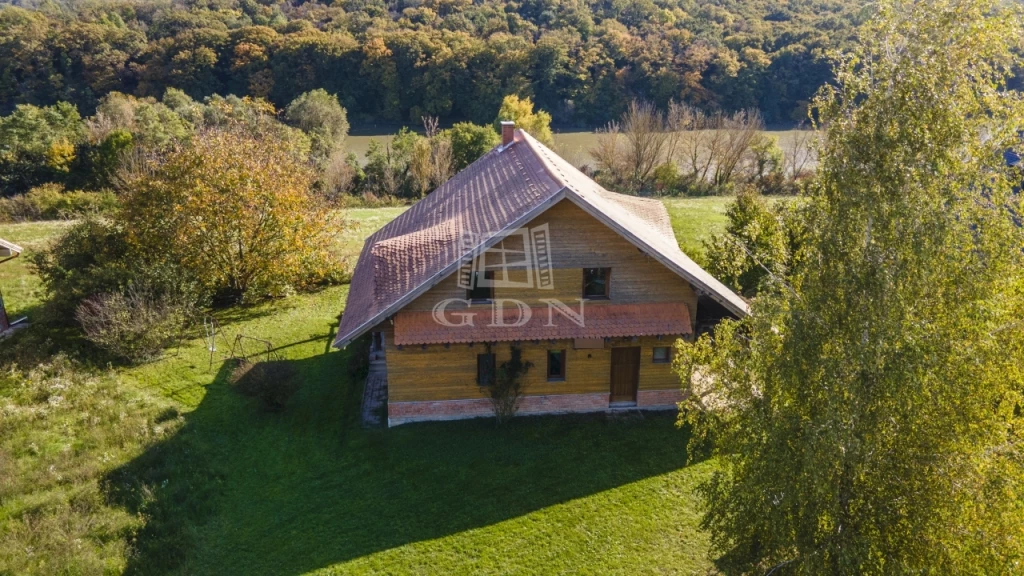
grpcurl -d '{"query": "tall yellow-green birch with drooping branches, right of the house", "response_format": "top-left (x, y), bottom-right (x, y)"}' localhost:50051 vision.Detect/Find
top-left (677, 0), bottom-right (1024, 574)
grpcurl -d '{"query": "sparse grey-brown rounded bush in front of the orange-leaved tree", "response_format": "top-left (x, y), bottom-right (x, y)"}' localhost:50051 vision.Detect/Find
top-left (75, 288), bottom-right (194, 363)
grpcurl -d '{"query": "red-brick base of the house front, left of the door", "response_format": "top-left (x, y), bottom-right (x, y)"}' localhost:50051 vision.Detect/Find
top-left (387, 393), bottom-right (610, 426)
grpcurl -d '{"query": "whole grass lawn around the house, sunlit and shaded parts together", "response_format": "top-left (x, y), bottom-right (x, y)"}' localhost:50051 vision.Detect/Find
top-left (0, 198), bottom-right (727, 574)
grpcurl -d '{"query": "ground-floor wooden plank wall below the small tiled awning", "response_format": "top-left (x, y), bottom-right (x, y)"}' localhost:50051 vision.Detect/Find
top-left (385, 335), bottom-right (679, 402)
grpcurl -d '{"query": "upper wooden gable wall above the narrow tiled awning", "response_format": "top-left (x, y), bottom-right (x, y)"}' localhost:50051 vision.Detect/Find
top-left (406, 200), bottom-right (697, 320)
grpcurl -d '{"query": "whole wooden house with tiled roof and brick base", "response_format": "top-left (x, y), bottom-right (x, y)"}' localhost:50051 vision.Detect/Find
top-left (334, 122), bottom-right (749, 425)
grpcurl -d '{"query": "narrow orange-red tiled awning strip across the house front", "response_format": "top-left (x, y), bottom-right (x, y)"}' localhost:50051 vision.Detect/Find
top-left (394, 302), bottom-right (692, 345)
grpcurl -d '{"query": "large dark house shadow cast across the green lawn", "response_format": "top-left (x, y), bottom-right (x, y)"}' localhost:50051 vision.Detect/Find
top-left (104, 342), bottom-right (700, 574)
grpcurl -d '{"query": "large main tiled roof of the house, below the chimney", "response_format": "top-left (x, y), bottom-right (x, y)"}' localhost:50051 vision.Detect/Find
top-left (335, 130), bottom-right (748, 346)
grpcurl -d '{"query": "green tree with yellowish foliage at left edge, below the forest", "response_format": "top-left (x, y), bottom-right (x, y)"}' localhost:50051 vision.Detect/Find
top-left (0, 102), bottom-right (83, 195)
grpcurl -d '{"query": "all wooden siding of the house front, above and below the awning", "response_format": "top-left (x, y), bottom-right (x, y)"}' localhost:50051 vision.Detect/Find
top-left (378, 201), bottom-right (697, 402)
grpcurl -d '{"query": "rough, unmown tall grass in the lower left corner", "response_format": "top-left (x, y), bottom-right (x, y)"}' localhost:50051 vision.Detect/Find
top-left (0, 357), bottom-right (183, 574)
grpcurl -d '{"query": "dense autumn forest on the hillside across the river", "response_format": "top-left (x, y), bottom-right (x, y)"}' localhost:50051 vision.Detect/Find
top-left (0, 0), bottom-right (871, 128)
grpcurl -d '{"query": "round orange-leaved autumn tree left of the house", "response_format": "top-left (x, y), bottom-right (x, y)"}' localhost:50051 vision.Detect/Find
top-left (117, 126), bottom-right (337, 302)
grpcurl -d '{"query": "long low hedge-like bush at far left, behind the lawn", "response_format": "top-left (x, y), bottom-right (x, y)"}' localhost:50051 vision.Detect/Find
top-left (0, 183), bottom-right (118, 222)
